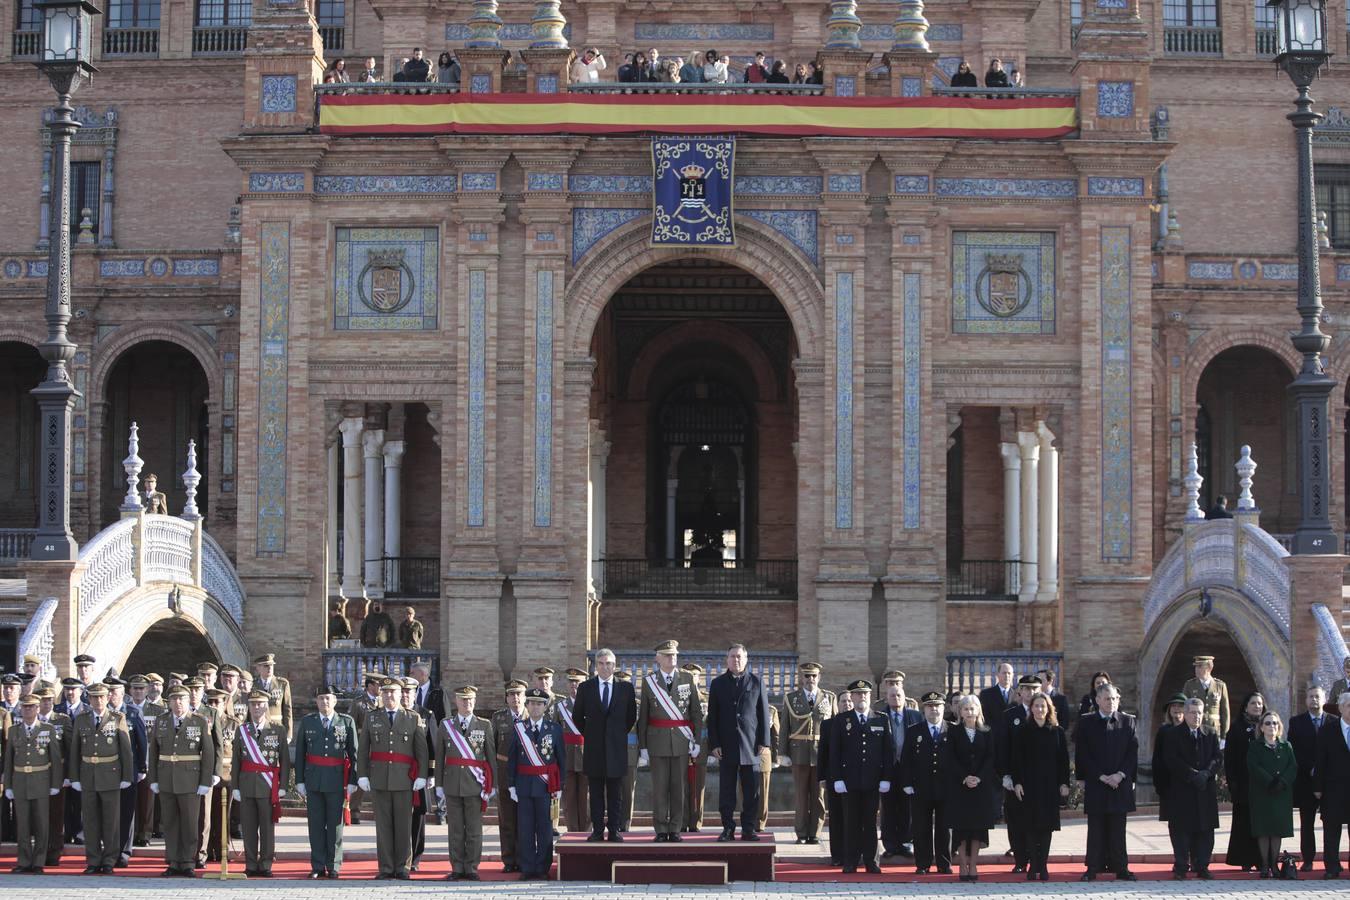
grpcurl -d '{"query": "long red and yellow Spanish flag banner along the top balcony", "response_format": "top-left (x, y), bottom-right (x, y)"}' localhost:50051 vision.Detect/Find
top-left (319, 93), bottom-right (1077, 139)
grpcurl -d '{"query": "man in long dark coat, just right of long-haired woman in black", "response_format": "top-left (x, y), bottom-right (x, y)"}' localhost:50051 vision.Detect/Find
top-left (1075, 683), bottom-right (1139, 881)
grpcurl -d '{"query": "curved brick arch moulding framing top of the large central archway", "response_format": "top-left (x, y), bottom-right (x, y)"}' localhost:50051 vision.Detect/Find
top-left (564, 221), bottom-right (825, 359)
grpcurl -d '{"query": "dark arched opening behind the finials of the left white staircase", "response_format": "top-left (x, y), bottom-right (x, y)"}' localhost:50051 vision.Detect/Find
top-left (100, 340), bottom-right (211, 525)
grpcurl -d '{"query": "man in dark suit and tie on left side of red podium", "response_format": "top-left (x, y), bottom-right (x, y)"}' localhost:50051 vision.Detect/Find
top-left (572, 650), bottom-right (637, 843)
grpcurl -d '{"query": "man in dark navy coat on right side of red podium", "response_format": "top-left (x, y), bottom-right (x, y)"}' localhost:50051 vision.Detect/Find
top-left (707, 644), bottom-right (772, 841)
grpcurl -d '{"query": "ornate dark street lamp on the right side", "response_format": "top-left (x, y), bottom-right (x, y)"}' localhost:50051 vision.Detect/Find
top-left (1268, 0), bottom-right (1341, 553)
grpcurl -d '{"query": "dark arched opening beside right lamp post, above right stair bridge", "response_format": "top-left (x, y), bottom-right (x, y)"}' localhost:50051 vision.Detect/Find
top-left (1195, 345), bottom-right (1299, 533)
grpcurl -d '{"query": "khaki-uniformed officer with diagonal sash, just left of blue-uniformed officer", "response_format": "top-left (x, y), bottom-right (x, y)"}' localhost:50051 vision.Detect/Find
top-left (435, 684), bottom-right (496, 881)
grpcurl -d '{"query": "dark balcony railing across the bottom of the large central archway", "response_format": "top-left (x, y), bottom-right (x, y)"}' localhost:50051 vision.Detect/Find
top-left (597, 559), bottom-right (797, 600)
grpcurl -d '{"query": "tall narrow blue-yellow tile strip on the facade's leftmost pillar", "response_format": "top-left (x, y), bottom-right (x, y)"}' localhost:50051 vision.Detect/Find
top-left (257, 221), bottom-right (290, 556)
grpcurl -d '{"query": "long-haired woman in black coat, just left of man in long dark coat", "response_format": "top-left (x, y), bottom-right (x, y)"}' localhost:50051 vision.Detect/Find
top-left (1008, 694), bottom-right (1069, 881)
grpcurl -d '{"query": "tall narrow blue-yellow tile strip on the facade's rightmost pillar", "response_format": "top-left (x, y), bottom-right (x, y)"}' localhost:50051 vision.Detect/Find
top-left (1100, 225), bottom-right (1134, 563)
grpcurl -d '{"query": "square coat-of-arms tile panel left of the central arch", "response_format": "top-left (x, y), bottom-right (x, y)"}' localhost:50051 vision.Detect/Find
top-left (333, 228), bottom-right (440, 331)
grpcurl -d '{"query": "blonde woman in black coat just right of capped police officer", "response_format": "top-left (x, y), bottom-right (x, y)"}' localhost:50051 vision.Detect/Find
top-left (938, 696), bottom-right (1000, 881)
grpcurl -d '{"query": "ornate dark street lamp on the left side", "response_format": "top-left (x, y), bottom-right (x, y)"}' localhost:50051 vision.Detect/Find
top-left (31, 0), bottom-right (99, 560)
